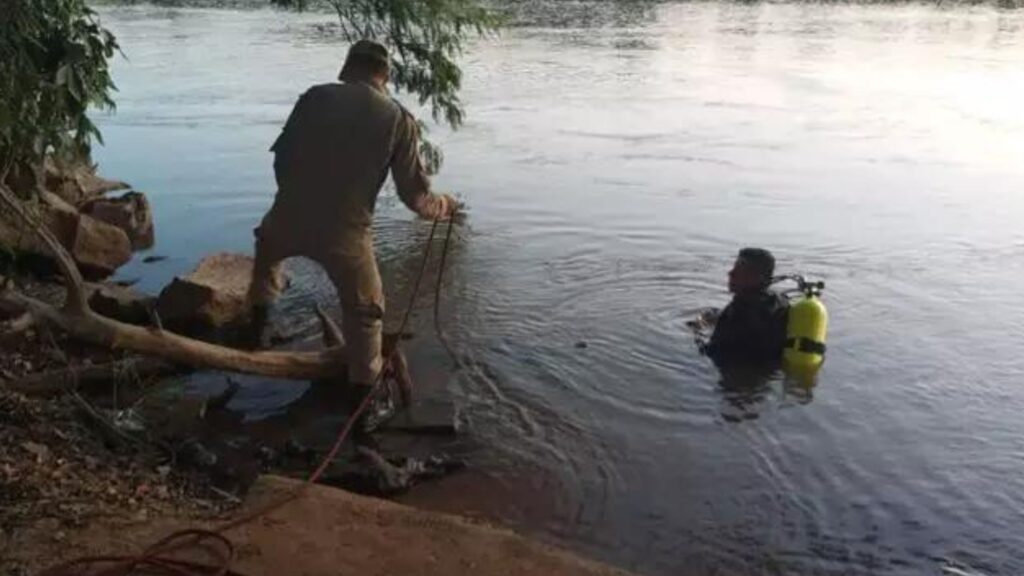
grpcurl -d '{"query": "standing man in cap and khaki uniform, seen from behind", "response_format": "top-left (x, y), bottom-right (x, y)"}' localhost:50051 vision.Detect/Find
top-left (249, 40), bottom-right (457, 405)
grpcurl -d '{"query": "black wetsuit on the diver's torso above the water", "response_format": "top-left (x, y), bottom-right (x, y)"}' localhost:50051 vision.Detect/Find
top-left (703, 290), bottom-right (790, 366)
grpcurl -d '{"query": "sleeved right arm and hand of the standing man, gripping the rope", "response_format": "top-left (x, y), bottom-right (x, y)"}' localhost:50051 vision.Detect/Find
top-left (391, 109), bottom-right (456, 220)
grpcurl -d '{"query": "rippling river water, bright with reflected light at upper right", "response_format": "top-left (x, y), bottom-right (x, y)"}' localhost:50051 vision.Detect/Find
top-left (96, 2), bottom-right (1024, 575)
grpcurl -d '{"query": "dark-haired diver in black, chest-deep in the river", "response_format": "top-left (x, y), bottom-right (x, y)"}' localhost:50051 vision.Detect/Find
top-left (697, 248), bottom-right (790, 367)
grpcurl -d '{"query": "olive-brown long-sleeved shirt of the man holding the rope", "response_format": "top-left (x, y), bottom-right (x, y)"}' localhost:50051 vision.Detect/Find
top-left (270, 82), bottom-right (443, 236)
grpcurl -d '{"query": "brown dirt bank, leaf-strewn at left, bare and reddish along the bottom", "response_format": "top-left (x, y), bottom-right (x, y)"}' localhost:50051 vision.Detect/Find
top-left (0, 373), bottom-right (623, 576)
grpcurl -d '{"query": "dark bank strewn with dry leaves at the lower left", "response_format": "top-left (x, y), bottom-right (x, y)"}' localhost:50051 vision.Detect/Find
top-left (0, 383), bottom-right (236, 574)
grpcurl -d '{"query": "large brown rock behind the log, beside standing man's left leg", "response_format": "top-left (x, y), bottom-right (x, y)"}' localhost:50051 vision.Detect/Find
top-left (157, 252), bottom-right (262, 331)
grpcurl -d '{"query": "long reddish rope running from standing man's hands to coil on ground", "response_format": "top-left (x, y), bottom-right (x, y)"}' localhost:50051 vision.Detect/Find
top-left (39, 215), bottom-right (455, 576)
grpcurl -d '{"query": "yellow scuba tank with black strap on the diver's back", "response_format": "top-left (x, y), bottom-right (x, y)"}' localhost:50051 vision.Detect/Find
top-left (782, 276), bottom-right (828, 376)
